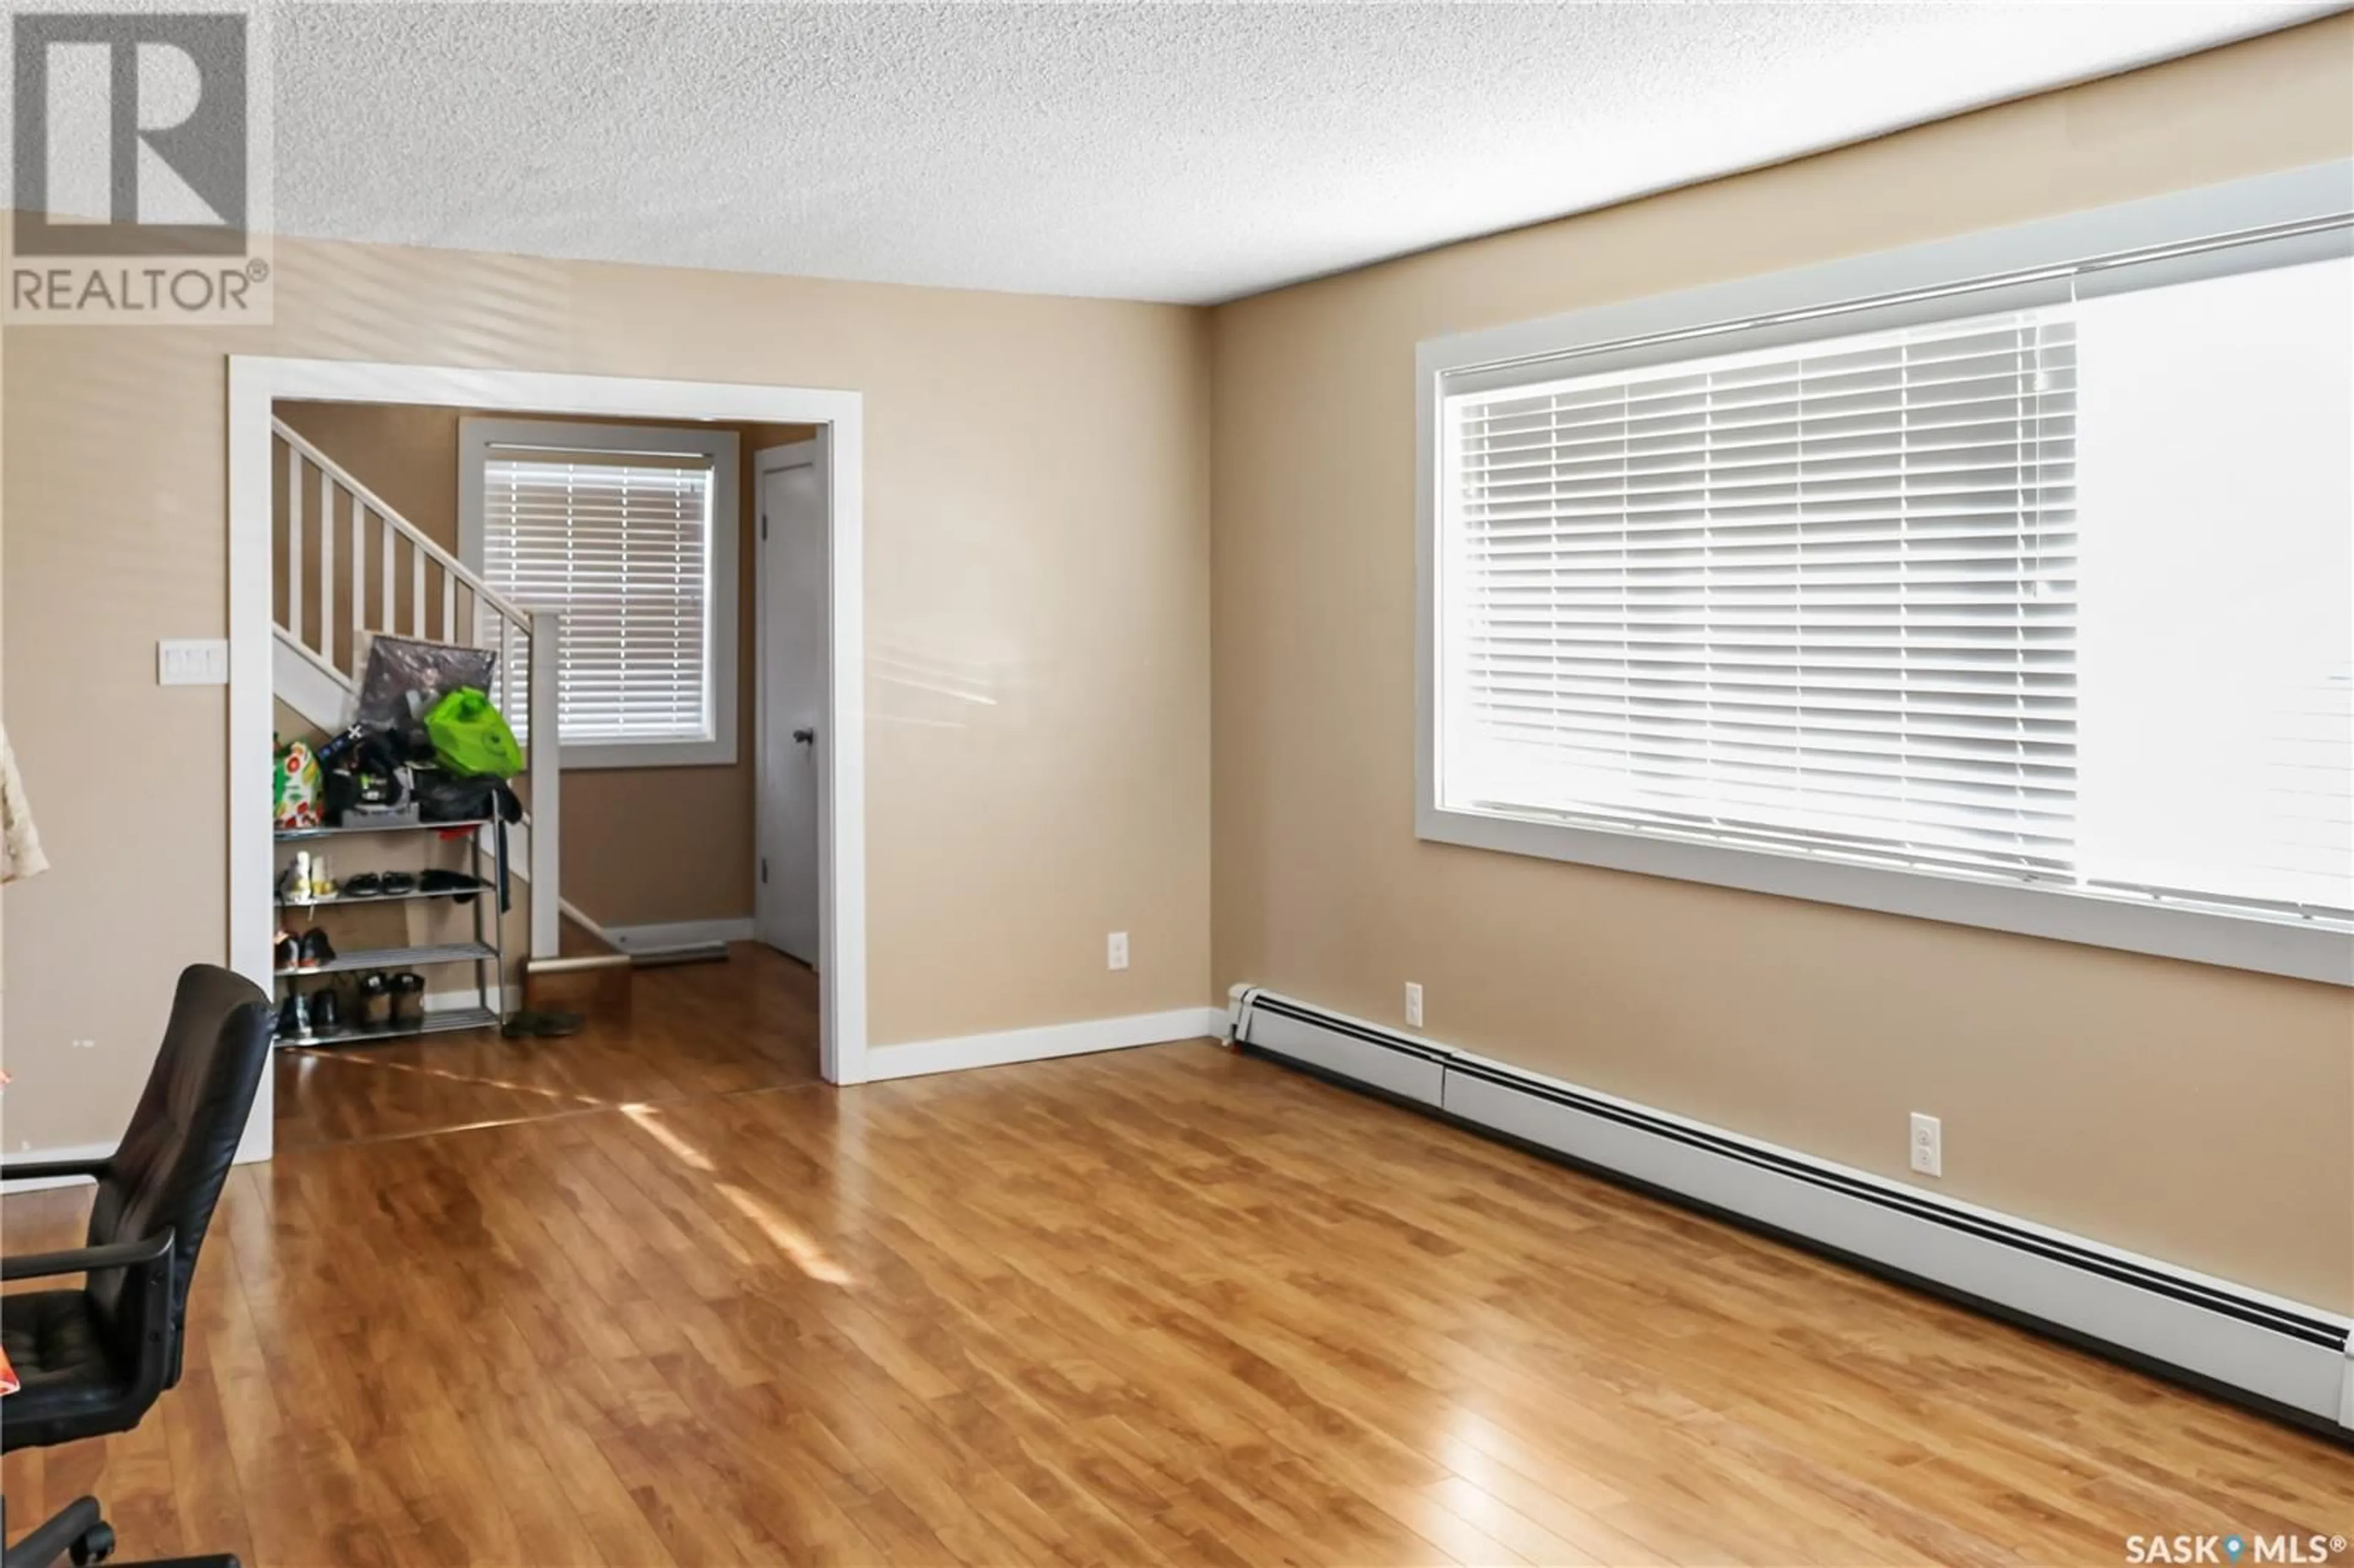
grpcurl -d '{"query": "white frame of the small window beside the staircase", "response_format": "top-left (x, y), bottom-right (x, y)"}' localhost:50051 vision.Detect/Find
top-left (457, 419), bottom-right (744, 767)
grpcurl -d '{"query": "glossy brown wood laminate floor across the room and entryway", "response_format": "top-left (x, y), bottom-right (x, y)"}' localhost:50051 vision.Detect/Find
top-left (0, 949), bottom-right (2354, 1566)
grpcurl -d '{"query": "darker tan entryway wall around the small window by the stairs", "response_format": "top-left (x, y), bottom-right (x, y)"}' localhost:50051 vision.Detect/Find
top-left (278, 403), bottom-right (812, 925)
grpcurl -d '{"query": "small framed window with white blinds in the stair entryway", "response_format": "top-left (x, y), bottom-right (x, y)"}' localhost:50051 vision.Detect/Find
top-left (462, 419), bottom-right (737, 767)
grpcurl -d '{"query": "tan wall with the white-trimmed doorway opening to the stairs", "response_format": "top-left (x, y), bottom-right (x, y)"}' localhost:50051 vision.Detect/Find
top-left (0, 240), bottom-right (1210, 1149)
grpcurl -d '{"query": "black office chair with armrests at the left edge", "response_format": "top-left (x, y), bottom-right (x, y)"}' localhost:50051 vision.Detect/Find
top-left (0, 963), bottom-right (273, 1568)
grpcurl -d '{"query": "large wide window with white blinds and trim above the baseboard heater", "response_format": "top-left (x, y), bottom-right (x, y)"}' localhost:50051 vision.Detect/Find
top-left (1422, 167), bottom-right (2354, 980)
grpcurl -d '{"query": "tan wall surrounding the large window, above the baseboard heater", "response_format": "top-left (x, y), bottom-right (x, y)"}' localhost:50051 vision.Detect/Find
top-left (1213, 19), bottom-right (2354, 1309)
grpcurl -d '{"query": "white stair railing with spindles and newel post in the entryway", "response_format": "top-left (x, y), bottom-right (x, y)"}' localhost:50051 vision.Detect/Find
top-left (271, 419), bottom-right (563, 958)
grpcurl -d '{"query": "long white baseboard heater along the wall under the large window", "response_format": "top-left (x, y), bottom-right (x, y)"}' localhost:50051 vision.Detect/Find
top-left (1233, 986), bottom-right (2354, 1441)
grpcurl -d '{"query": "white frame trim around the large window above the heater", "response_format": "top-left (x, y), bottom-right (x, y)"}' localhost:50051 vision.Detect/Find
top-left (1415, 162), bottom-right (2354, 986)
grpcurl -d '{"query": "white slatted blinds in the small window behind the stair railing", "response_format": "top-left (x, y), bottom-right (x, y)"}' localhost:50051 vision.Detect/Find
top-left (482, 450), bottom-right (714, 747)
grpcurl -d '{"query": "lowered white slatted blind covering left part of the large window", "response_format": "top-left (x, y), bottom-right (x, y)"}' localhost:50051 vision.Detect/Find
top-left (1438, 313), bottom-right (2076, 878)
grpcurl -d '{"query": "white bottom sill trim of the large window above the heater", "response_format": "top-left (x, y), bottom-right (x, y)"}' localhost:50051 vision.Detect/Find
top-left (1415, 805), bottom-right (2354, 986)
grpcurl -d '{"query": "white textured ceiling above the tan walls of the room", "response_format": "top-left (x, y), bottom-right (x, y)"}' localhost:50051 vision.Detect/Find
top-left (257, 0), bottom-right (2340, 302)
